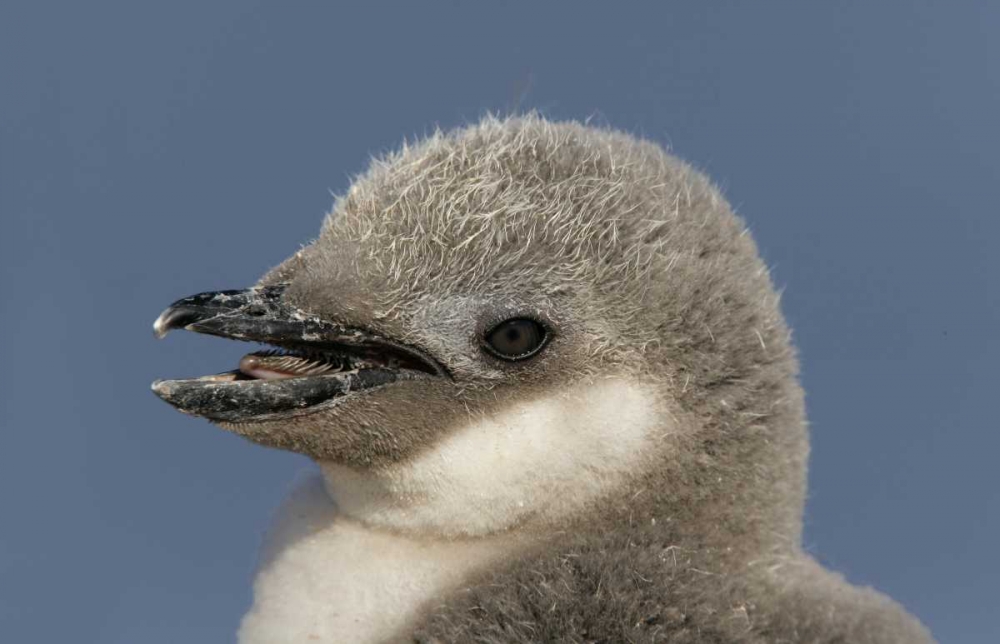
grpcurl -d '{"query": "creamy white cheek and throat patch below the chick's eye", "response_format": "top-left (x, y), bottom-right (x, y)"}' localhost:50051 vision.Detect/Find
top-left (321, 378), bottom-right (673, 536)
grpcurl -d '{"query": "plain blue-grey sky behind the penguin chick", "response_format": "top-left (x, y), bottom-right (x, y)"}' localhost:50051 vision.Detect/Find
top-left (0, 0), bottom-right (1000, 644)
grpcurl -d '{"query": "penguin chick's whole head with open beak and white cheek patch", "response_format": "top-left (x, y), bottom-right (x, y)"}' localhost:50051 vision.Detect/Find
top-left (154, 115), bottom-right (800, 533)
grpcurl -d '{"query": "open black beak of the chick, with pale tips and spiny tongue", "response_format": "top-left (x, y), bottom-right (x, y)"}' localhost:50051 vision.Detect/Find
top-left (153, 285), bottom-right (447, 423)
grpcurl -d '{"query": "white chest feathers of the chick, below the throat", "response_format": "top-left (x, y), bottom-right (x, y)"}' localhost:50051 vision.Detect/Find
top-left (239, 475), bottom-right (504, 644)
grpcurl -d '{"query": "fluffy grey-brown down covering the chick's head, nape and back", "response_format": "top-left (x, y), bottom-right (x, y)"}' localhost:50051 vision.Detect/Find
top-left (182, 116), bottom-right (931, 644)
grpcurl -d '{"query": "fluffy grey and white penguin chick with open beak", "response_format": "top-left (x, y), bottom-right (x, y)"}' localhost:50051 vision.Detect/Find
top-left (153, 115), bottom-right (932, 644)
